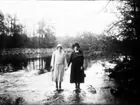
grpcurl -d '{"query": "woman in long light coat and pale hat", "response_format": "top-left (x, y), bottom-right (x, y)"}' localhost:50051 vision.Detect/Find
top-left (51, 44), bottom-right (67, 91)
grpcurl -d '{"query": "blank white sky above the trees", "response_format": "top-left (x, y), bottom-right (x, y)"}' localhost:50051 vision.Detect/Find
top-left (0, 0), bottom-right (120, 36)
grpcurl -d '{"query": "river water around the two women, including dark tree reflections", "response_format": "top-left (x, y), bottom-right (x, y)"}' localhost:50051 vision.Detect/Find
top-left (0, 50), bottom-right (139, 105)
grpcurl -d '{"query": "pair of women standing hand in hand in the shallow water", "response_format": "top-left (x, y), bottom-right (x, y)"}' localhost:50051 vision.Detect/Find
top-left (51, 43), bottom-right (85, 90)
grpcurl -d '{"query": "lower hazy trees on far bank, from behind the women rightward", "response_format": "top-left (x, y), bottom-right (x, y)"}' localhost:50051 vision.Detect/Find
top-left (57, 32), bottom-right (122, 53)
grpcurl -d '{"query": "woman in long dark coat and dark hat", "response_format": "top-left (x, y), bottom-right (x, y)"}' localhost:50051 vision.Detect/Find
top-left (68, 43), bottom-right (84, 89)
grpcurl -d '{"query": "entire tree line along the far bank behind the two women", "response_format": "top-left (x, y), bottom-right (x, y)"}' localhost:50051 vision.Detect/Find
top-left (0, 8), bottom-right (121, 52)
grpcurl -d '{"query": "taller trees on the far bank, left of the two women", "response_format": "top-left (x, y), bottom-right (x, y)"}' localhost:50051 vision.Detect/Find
top-left (0, 12), bottom-right (56, 49)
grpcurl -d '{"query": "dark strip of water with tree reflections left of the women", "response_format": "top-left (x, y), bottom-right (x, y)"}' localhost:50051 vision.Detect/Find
top-left (0, 54), bottom-right (51, 71)
